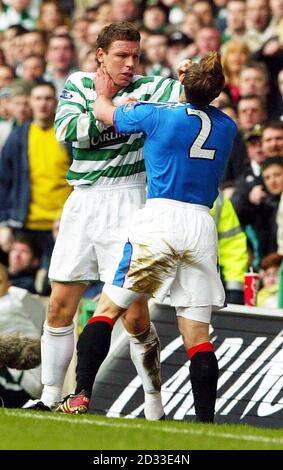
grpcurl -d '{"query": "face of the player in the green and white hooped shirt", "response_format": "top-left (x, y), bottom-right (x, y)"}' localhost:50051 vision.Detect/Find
top-left (97, 41), bottom-right (140, 89)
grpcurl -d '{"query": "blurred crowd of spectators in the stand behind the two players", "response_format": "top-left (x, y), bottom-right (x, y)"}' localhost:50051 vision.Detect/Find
top-left (0, 0), bottom-right (283, 304)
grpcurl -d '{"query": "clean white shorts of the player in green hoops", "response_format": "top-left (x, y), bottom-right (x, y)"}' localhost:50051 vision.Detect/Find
top-left (49, 184), bottom-right (145, 282)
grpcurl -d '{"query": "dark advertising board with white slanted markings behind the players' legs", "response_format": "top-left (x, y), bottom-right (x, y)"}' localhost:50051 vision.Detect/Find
top-left (91, 301), bottom-right (283, 428)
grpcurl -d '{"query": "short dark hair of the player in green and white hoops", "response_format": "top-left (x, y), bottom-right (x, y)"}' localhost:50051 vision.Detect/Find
top-left (96, 21), bottom-right (141, 52)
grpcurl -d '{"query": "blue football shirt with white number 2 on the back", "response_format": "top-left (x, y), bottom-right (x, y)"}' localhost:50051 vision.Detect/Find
top-left (114, 102), bottom-right (237, 208)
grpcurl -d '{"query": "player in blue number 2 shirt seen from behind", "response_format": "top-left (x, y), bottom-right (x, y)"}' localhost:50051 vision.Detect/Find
top-left (88, 52), bottom-right (236, 422)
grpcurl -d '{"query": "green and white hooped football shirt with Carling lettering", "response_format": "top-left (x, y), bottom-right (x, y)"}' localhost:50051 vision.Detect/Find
top-left (55, 72), bottom-right (182, 186)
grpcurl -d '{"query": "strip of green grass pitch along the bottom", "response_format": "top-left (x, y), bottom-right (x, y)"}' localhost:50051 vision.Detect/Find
top-left (0, 409), bottom-right (283, 450)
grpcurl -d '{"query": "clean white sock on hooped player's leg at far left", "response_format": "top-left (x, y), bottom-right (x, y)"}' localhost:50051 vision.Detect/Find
top-left (41, 322), bottom-right (74, 406)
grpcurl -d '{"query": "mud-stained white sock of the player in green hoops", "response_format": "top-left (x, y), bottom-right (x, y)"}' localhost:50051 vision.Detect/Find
top-left (130, 323), bottom-right (164, 420)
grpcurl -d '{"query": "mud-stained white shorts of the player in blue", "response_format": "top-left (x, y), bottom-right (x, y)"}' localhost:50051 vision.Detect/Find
top-left (104, 199), bottom-right (225, 308)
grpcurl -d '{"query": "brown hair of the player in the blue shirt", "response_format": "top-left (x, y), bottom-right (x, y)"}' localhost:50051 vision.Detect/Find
top-left (184, 51), bottom-right (225, 107)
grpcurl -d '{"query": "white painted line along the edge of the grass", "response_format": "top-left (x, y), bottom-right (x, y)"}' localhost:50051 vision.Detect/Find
top-left (4, 410), bottom-right (283, 445)
